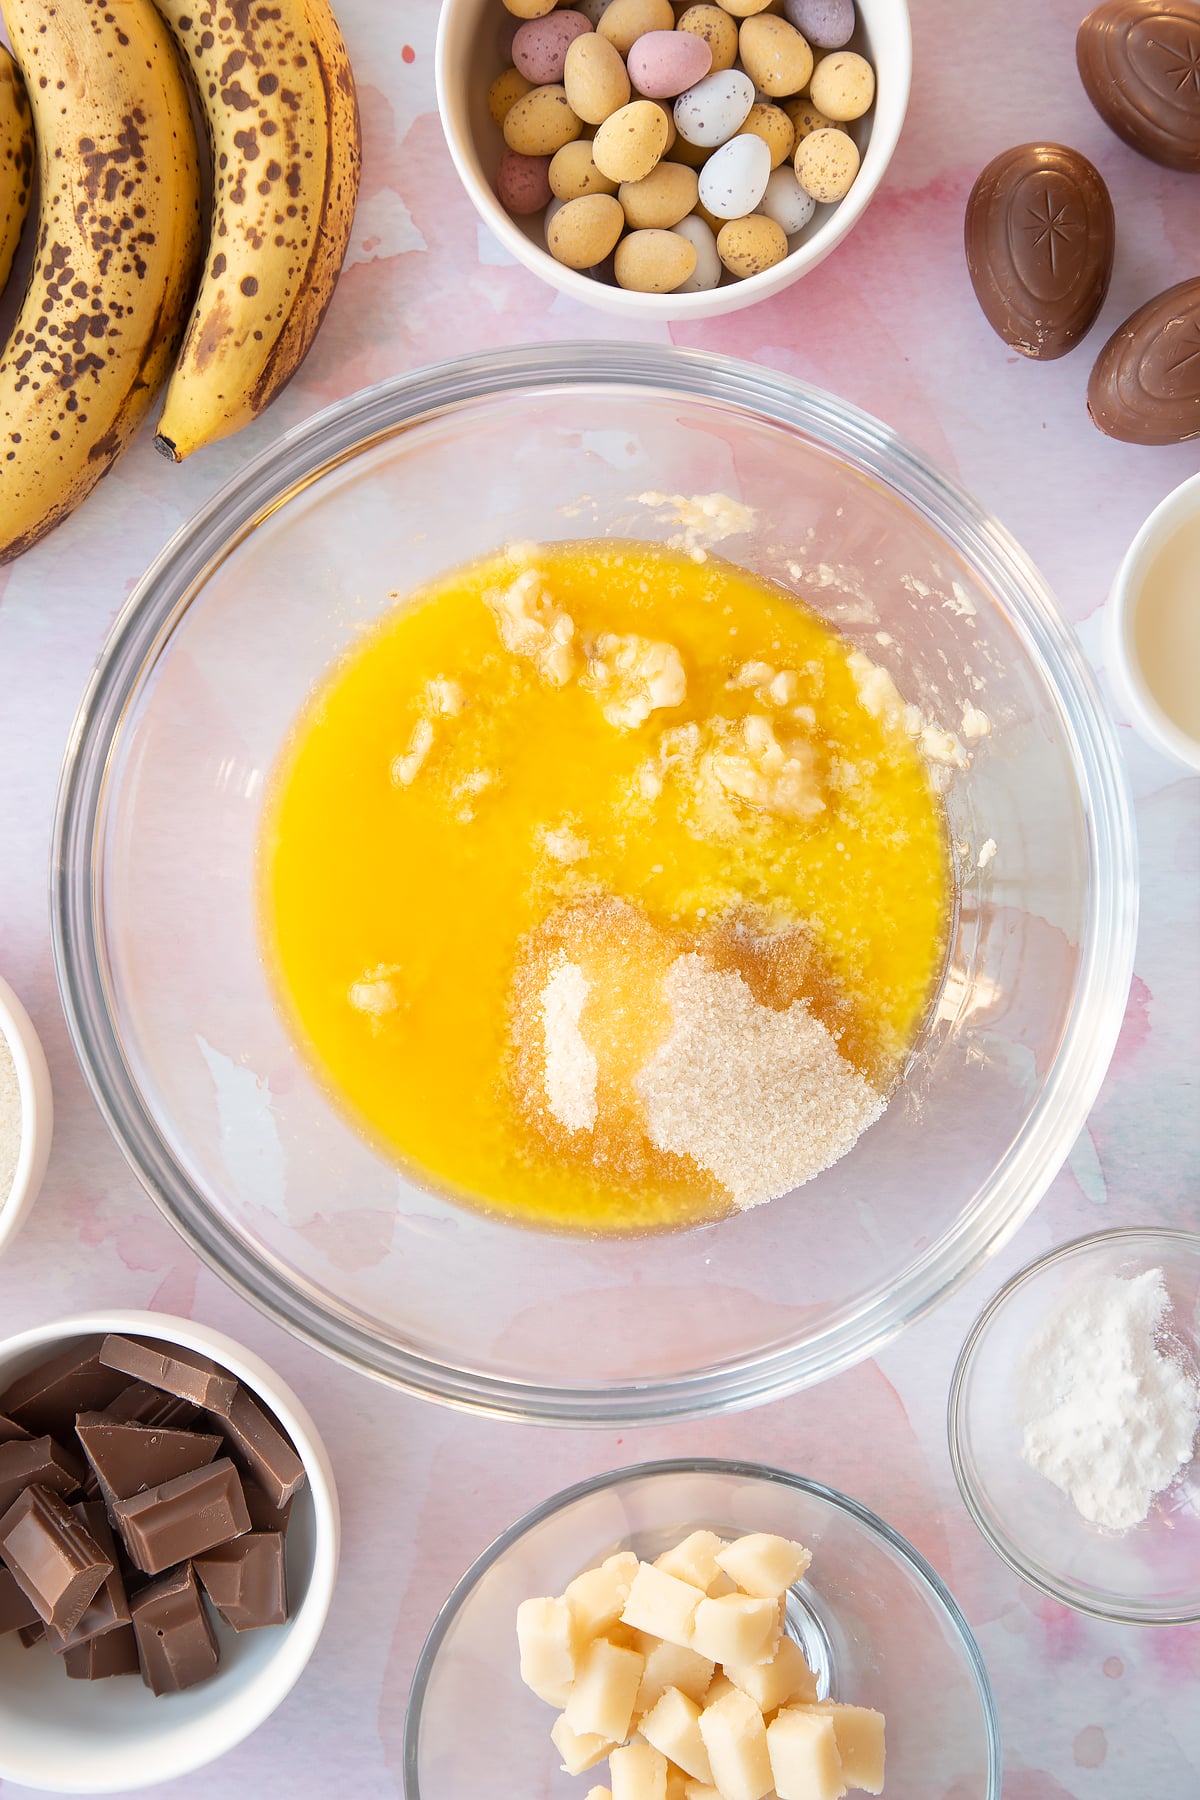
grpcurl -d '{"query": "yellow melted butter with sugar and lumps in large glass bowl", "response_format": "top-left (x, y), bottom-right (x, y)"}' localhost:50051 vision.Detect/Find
top-left (261, 540), bottom-right (957, 1231)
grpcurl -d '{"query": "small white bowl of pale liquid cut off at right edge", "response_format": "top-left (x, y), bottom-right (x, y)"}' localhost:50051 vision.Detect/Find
top-left (1108, 475), bottom-right (1200, 774)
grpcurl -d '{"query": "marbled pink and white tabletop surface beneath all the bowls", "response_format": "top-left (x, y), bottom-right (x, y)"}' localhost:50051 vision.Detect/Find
top-left (0, 0), bottom-right (1200, 1800)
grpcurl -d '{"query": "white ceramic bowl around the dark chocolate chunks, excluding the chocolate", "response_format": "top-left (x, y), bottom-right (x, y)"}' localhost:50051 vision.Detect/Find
top-left (0, 1312), bottom-right (342, 1795)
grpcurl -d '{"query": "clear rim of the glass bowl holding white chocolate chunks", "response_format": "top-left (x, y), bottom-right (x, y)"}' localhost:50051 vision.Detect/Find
top-left (403, 1456), bottom-right (1004, 1800)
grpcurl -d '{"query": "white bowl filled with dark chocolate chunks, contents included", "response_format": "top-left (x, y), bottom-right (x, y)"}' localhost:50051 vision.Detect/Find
top-left (0, 1312), bottom-right (340, 1795)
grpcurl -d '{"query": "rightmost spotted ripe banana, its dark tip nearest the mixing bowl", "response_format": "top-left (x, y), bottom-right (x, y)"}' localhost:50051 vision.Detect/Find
top-left (155, 0), bottom-right (362, 463)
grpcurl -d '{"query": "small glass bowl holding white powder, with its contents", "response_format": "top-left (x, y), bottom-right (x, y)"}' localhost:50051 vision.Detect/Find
top-left (948, 1229), bottom-right (1200, 1625)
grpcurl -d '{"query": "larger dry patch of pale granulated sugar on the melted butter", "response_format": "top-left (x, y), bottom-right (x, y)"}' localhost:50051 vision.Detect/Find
top-left (637, 956), bottom-right (883, 1208)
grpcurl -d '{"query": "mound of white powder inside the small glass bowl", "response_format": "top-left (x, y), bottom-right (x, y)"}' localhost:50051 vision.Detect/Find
top-left (1022, 1269), bottom-right (1200, 1530)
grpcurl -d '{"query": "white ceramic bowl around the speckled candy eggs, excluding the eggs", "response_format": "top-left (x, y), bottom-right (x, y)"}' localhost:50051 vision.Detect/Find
top-left (435, 0), bottom-right (912, 320)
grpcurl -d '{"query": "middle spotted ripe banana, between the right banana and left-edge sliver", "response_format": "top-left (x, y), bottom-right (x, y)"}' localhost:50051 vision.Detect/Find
top-left (0, 0), bottom-right (201, 562)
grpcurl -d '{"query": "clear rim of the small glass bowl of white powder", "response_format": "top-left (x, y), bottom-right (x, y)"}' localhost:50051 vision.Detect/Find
top-left (946, 1226), bottom-right (1200, 1625)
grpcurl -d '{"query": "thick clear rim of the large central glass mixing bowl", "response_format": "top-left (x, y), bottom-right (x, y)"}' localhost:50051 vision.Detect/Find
top-left (50, 340), bottom-right (1137, 1426)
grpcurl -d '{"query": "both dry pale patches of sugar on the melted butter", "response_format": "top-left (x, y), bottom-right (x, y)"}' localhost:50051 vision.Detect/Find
top-left (542, 952), bottom-right (883, 1210)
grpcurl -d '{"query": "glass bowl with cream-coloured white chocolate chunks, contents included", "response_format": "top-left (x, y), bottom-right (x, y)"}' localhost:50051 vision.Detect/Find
top-left (405, 1462), bottom-right (1000, 1800)
